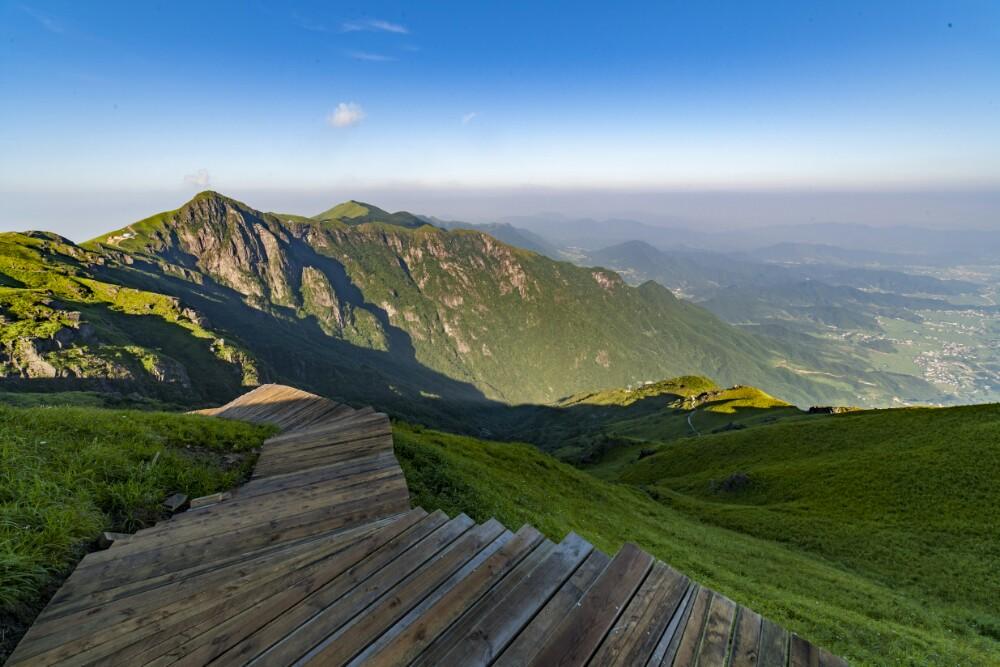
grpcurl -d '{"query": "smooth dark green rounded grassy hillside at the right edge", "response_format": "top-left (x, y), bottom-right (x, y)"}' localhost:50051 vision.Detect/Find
top-left (620, 405), bottom-right (1000, 639)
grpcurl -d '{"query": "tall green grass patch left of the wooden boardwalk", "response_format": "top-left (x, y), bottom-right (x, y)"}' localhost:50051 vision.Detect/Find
top-left (0, 404), bottom-right (271, 661)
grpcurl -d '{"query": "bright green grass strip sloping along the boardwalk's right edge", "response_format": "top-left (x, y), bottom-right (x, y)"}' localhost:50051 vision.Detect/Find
top-left (394, 416), bottom-right (1000, 665)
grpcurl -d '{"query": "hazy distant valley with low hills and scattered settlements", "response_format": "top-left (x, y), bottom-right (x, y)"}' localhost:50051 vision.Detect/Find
top-left (456, 218), bottom-right (1000, 405)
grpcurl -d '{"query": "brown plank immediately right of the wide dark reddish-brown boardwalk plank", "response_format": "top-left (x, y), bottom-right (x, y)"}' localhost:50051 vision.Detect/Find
top-left (590, 561), bottom-right (690, 665)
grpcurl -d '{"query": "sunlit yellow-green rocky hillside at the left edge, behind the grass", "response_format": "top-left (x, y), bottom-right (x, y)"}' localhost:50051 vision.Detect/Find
top-left (0, 233), bottom-right (258, 401)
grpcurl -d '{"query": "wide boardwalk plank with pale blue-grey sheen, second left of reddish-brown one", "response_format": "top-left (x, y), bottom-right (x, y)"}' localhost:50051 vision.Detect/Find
top-left (430, 533), bottom-right (593, 665)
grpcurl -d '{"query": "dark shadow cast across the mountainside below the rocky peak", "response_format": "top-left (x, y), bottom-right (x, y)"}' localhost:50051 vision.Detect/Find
top-left (88, 253), bottom-right (508, 433)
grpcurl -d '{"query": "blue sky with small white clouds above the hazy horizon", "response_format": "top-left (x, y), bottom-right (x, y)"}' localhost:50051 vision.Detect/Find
top-left (0, 0), bottom-right (1000, 236)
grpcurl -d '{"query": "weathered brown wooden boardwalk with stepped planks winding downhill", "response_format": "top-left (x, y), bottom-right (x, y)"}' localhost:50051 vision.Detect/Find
top-left (9, 385), bottom-right (846, 667)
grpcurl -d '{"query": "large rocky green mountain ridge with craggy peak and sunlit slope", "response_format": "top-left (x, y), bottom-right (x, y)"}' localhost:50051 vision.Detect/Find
top-left (76, 193), bottom-right (920, 412)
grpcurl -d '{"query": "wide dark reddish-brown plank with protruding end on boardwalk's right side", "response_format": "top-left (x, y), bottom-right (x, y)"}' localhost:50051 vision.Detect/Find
top-left (531, 544), bottom-right (653, 667)
